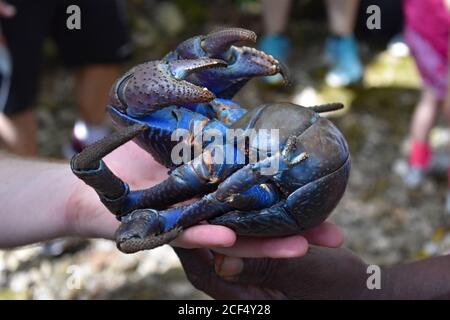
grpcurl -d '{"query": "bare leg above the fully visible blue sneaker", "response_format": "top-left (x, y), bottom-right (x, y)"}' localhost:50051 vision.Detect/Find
top-left (326, 0), bottom-right (359, 36)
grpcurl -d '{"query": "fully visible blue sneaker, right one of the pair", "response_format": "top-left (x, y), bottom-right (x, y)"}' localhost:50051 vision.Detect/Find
top-left (325, 36), bottom-right (363, 87)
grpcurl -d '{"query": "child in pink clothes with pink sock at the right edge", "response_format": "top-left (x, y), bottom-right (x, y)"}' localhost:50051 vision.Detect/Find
top-left (403, 0), bottom-right (450, 212)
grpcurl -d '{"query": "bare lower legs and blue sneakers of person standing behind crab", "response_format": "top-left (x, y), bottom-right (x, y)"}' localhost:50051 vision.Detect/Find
top-left (259, 0), bottom-right (363, 86)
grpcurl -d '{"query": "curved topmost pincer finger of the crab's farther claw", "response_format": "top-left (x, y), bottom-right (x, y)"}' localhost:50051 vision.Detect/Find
top-left (201, 28), bottom-right (256, 59)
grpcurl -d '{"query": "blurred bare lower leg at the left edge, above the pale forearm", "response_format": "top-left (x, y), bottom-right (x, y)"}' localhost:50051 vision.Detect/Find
top-left (0, 109), bottom-right (37, 156)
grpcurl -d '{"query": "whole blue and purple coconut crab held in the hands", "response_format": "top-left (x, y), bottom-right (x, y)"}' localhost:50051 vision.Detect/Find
top-left (71, 28), bottom-right (350, 253)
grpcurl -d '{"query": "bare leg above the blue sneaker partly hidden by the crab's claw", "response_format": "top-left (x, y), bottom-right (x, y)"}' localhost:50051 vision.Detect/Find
top-left (262, 0), bottom-right (291, 35)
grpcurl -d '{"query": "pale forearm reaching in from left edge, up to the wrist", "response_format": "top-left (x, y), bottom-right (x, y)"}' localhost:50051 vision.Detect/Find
top-left (0, 152), bottom-right (78, 248)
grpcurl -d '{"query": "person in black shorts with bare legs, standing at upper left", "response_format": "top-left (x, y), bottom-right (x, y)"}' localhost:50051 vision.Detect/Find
top-left (0, 0), bottom-right (131, 157)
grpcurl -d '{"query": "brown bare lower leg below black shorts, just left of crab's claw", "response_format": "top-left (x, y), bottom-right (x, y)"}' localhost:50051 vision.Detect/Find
top-left (75, 65), bottom-right (120, 125)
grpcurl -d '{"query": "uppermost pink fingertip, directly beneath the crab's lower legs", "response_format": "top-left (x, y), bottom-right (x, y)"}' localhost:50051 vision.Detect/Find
top-left (171, 225), bottom-right (236, 249)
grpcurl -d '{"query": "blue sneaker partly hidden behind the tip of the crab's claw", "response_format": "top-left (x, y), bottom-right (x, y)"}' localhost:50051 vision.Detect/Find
top-left (258, 35), bottom-right (290, 85)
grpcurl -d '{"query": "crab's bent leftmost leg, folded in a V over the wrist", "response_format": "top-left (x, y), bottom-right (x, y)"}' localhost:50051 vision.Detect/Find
top-left (71, 124), bottom-right (218, 216)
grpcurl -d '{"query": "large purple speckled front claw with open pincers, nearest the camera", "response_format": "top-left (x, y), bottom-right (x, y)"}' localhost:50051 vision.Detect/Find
top-left (110, 58), bottom-right (226, 116)
